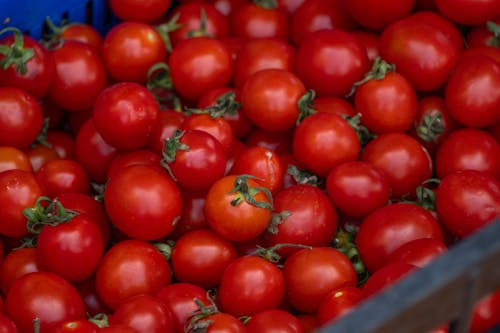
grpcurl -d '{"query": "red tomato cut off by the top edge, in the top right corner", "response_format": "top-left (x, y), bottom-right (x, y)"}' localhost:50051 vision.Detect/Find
top-left (435, 0), bottom-right (500, 25)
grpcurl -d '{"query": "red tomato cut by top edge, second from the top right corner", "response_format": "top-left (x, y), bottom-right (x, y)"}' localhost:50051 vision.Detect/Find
top-left (343, 0), bottom-right (416, 30)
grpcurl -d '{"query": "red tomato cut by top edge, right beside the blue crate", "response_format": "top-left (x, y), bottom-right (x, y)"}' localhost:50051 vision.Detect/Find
top-left (109, 0), bottom-right (172, 22)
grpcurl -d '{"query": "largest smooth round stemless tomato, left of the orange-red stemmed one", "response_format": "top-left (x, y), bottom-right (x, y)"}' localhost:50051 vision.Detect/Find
top-left (104, 165), bottom-right (182, 240)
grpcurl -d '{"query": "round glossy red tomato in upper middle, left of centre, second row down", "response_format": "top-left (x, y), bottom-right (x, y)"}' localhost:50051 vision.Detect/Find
top-left (168, 37), bottom-right (233, 101)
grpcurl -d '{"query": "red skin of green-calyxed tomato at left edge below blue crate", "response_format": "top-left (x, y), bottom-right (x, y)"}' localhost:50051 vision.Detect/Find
top-left (0, 35), bottom-right (54, 100)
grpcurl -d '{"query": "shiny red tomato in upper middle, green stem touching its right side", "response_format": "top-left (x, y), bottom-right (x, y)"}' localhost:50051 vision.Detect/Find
top-left (241, 68), bottom-right (306, 132)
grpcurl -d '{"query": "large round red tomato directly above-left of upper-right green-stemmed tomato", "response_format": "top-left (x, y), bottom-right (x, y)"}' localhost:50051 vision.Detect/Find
top-left (296, 29), bottom-right (370, 97)
